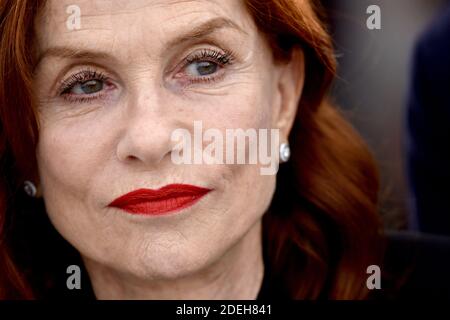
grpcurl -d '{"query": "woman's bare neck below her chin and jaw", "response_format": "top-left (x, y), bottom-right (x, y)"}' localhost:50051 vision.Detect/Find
top-left (83, 221), bottom-right (264, 300)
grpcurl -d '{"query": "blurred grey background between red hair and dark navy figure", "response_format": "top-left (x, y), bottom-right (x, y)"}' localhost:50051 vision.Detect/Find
top-left (322, 0), bottom-right (449, 230)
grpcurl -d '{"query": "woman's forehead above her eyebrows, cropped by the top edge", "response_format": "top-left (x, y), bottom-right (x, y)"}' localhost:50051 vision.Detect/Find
top-left (36, 0), bottom-right (254, 49)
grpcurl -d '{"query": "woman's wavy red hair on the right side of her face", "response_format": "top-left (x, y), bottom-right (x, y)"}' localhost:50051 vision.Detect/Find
top-left (246, 0), bottom-right (383, 299)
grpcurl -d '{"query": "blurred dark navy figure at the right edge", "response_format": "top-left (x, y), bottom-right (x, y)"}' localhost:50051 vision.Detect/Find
top-left (407, 7), bottom-right (450, 235)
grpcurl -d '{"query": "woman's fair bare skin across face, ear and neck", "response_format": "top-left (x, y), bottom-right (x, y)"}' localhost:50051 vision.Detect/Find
top-left (34, 0), bottom-right (304, 299)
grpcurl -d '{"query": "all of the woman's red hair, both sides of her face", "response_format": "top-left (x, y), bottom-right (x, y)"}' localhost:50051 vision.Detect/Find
top-left (0, 0), bottom-right (381, 299)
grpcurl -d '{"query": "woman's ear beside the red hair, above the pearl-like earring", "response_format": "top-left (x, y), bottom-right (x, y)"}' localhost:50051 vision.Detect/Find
top-left (273, 48), bottom-right (305, 140)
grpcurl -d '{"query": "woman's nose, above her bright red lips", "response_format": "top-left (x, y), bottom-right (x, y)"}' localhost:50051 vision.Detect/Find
top-left (116, 86), bottom-right (175, 166)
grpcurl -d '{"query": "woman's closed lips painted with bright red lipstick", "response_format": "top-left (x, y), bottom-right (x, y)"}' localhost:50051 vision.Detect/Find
top-left (108, 184), bottom-right (211, 216)
